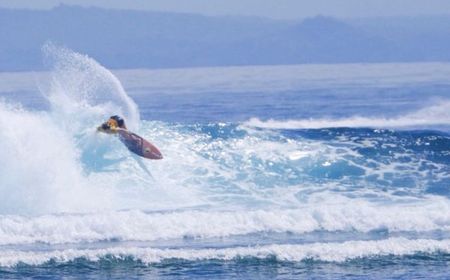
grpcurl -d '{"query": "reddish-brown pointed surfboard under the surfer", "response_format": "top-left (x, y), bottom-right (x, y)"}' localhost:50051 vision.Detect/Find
top-left (118, 129), bottom-right (163, 159)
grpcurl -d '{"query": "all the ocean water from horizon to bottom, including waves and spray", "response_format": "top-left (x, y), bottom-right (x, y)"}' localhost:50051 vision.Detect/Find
top-left (0, 46), bottom-right (450, 279)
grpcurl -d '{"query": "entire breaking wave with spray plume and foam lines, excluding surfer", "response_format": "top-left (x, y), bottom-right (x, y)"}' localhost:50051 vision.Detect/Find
top-left (0, 44), bottom-right (450, 272)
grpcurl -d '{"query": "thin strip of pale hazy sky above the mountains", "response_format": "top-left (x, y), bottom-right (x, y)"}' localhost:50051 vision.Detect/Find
top-left (0, 0), bottom-right (450, 19)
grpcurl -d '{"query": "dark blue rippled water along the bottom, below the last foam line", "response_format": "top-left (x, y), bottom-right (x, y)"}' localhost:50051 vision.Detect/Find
top-left (1, 254), bottom-right (450, 279)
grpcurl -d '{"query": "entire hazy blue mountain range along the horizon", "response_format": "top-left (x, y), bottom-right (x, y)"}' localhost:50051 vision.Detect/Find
top-left (0, 5), bottom-right (450, 71)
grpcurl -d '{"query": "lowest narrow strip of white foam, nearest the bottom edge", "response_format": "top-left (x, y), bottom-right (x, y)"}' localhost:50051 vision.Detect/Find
top-left (0, 238), bottom-right (450, 267)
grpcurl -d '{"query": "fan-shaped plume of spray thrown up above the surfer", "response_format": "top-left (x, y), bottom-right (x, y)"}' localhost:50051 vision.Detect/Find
top-left (42, 43), bottom-right (139, 130)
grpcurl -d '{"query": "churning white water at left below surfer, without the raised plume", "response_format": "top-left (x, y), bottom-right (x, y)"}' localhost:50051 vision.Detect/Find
top-left (0, 103), bottom-right (202, 215)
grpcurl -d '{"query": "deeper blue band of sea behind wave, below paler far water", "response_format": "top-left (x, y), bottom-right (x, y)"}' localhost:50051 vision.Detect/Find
top-left (7, 85), bottom-right (449, 123)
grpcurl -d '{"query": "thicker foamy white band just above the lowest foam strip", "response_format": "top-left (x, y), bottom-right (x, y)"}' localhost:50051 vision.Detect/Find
top-left (0, 195), bottom-right (450, 245)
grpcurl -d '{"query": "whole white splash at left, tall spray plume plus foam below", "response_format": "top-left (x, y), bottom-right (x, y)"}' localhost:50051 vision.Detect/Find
top-left (0, 44), bottom-right (186, 215)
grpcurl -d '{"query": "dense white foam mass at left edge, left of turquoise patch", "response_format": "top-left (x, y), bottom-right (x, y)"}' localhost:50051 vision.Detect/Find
top-left (0, 104), bottom-right (107, 213)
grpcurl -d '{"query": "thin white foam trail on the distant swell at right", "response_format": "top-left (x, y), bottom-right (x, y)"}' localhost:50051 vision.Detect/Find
top-left (245, 101), bottom-right (450, 129)
